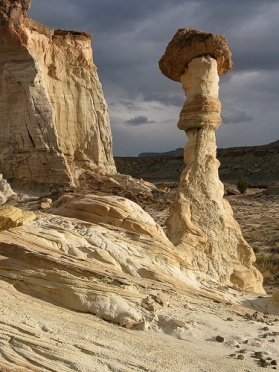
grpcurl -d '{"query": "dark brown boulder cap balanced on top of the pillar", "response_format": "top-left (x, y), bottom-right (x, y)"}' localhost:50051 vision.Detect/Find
top-left (159, 28), bottom-right (233, 81)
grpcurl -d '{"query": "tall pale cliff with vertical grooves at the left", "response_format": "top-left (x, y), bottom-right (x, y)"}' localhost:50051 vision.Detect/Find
top-left (0, 0), bottom-right (115, 184)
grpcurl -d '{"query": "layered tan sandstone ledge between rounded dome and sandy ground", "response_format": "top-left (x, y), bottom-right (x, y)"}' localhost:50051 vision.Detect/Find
top-left (0, 214), bottom-right (197, 328)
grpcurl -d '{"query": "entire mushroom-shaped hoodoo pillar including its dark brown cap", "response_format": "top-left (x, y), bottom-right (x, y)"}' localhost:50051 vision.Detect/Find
top-left (159, 29), bottom-right (264, 292)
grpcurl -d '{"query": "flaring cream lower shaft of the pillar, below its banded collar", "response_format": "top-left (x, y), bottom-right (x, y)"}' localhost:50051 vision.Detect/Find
top-left (166, 128), bottom-right (264, 293)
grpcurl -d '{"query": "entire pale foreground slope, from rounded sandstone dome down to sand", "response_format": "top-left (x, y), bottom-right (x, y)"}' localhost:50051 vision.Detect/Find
top-left (0, 189), bottom-right (279, 372)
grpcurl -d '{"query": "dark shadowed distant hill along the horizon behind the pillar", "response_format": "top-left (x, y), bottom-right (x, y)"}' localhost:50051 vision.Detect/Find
top-left (114, 140), bottom-right (279, 186)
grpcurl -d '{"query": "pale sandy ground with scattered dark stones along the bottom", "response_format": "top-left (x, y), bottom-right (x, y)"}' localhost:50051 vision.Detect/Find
top-left (0, 276), bottom-right (279, 372)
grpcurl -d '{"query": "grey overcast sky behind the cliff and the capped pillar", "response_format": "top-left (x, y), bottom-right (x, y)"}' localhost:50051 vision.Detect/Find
top-left (29, 0), bottom-right (279, 156)
